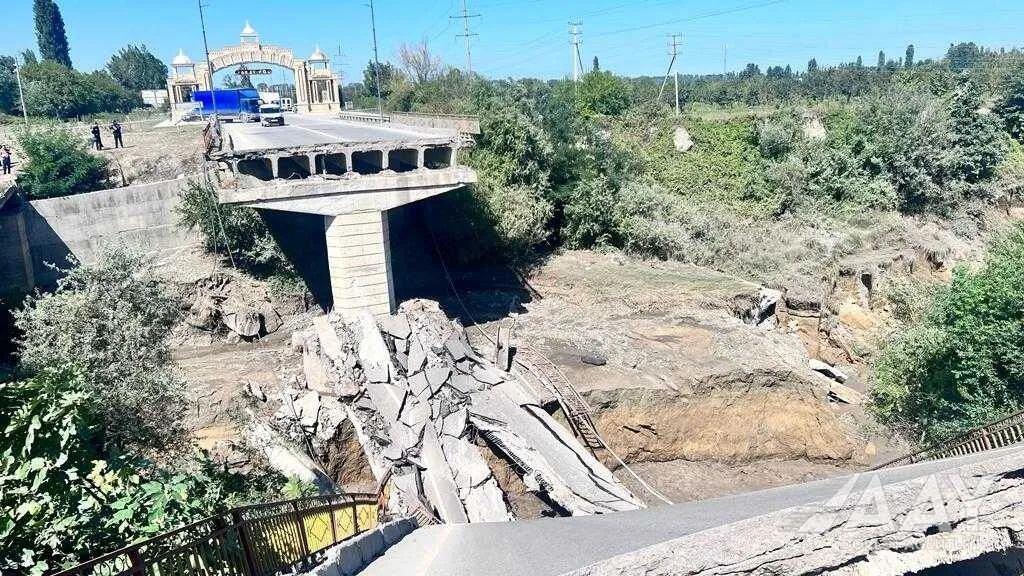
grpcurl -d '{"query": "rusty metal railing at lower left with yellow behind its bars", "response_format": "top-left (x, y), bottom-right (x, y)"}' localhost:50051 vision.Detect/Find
top-left (51, 494), bottom-right (378, 576)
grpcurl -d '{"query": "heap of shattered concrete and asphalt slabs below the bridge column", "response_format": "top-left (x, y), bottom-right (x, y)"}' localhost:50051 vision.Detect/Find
top-left (288, 300), bottom-right (642, 523)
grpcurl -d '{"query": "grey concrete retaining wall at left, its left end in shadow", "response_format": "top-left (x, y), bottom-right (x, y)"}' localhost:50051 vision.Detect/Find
top-left (0, 176), bottom-right (199, 293)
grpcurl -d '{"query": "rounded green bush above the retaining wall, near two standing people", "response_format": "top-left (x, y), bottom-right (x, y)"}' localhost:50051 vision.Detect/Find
top-left (17, 126), bottom-right (110, 199)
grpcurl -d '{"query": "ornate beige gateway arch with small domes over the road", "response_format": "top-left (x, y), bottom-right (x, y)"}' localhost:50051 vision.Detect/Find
top-left (167, 22), bottom-right (341, 116)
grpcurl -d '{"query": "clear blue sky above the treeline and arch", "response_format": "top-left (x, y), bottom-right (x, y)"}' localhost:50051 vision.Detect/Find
top-left (0, 0), bottom-right (1024, 83)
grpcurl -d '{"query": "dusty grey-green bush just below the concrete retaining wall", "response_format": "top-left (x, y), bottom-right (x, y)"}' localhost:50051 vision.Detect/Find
top-left (14, 246), bottom-right (184, 447)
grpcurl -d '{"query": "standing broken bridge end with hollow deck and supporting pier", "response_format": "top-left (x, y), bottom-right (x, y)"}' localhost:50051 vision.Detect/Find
top-left (208, 116), bottom-right (476, 315)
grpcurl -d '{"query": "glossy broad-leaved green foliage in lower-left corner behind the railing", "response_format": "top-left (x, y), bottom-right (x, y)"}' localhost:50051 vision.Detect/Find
top-left (0, 368), bottom-right (284, 576)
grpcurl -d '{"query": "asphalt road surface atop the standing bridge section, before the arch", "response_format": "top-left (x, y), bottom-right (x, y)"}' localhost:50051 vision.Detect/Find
top-left (223, 114), bottom-right (438, 152)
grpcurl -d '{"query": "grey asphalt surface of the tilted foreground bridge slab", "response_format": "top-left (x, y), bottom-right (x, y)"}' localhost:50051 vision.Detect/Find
top-left (360, 446), bottom-right (1024, 576)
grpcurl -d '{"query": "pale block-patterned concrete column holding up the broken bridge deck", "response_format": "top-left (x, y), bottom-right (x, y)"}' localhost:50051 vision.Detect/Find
top-left (324, 211), bottom-right (394, 315)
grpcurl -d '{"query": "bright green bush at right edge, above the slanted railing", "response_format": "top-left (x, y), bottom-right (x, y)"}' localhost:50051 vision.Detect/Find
top-left (871, 227), bottom-right (1024, 440)
